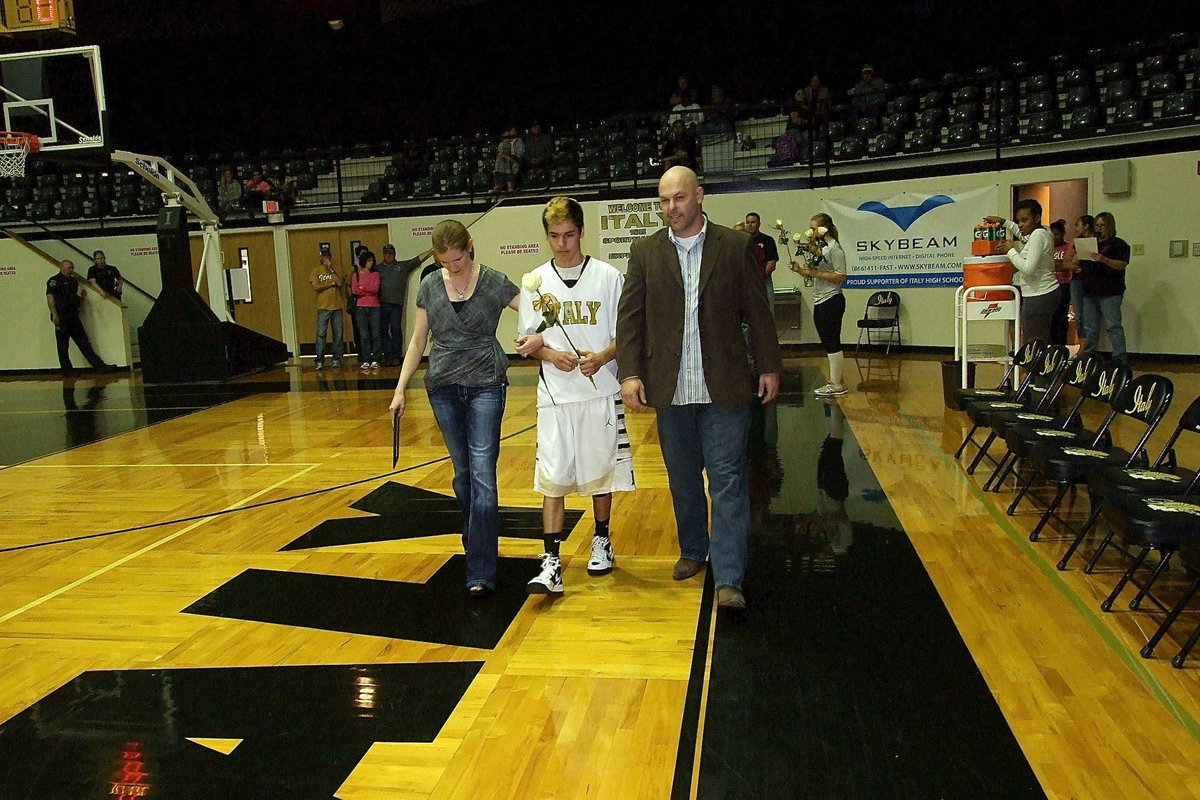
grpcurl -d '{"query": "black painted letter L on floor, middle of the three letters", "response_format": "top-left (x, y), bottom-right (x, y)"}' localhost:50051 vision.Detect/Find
top-left (184, 555), bottom-right (539, 650)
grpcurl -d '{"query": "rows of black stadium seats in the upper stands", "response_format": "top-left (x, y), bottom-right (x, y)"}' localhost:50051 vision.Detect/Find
top-left (0, 32), bottom-right (1200, 228)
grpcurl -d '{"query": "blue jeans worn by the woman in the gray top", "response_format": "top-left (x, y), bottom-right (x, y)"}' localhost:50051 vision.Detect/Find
top-left (430, 384), bottom-right (505, 589)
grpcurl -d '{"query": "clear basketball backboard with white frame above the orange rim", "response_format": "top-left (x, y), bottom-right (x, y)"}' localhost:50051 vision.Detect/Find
top-left (0, 46), bottom-right (110, 157)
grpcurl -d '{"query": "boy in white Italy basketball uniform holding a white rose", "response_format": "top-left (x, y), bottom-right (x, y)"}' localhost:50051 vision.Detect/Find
top-left (517, 197), bottom-right (634, 594)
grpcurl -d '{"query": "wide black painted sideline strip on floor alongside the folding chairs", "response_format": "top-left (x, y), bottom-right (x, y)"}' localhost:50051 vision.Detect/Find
top-left (671, 377), bottom-right (1045, 800)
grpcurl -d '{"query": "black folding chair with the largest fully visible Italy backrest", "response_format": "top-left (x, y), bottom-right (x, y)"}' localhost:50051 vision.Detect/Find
top-left (1008, 375), bottom-right (1175, 541)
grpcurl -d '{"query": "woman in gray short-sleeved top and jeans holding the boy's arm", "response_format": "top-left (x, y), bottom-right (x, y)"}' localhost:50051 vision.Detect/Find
top-left (390, 219), bottom-right (520, 597)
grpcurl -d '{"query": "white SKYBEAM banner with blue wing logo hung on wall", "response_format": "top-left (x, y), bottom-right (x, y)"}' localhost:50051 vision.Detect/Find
top-left (821, 186), bottom-right (1000, 289)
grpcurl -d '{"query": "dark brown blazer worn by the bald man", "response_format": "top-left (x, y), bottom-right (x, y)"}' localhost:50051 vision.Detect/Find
top-left (617, 222), bottom-right (782, 411)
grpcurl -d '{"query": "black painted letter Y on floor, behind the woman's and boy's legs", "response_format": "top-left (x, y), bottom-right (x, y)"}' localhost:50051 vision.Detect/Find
top-left (282, 481), bottom-right (583, 551)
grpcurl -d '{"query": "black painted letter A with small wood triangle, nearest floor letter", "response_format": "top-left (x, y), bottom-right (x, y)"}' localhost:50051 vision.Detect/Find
top-left (0, 661), bottom-right (482, 800)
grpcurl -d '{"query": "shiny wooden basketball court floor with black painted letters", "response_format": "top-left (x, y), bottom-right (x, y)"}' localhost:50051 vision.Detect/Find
top-left (0, 355), bottom-right (1200, 800)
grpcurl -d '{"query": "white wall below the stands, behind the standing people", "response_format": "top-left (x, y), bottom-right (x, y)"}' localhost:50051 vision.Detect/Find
top-left (0, 152), bottom-right (1200, 369)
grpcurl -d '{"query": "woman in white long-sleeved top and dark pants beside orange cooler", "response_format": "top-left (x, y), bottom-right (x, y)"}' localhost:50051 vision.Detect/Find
top-left (986, 198), bottom-right (1058, 342)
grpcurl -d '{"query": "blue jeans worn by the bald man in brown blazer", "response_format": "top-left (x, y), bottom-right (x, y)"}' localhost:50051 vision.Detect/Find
top-left (655, 403), bottom-right (750, 589)
